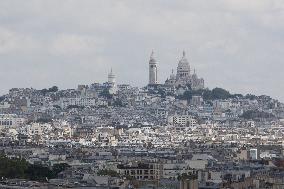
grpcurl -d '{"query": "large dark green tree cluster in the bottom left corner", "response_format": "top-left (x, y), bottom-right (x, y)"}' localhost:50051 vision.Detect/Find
top-left (0, 154), bottom-right (70, 181)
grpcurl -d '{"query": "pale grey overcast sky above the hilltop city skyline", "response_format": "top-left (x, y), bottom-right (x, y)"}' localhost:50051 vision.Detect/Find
top-left (0, 0), bottom-right (284, 102)
